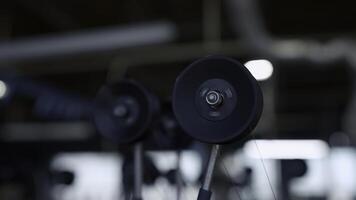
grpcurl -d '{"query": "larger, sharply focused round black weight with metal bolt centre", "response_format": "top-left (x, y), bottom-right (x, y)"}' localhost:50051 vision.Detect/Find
top-left (173, 56), bottom-right (263, 144)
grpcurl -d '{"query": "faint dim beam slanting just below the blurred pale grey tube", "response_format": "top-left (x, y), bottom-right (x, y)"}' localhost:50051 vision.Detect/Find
top-left (0, 40), bottom-right (248, 75)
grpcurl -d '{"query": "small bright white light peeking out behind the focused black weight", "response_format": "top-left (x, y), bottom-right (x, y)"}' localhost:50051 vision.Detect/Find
top-left (245, 59), bottom-right (273, 81)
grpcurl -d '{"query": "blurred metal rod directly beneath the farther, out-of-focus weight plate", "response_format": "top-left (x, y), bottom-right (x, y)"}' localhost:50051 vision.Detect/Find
top-left (134, 142), bottom-right (143, 200)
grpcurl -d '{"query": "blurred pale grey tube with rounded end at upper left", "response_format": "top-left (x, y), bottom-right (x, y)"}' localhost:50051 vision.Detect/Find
top-left (0, 22), bottom-right (176, 63)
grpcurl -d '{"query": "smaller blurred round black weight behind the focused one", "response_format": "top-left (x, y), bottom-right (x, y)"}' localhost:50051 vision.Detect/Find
top-left (94, 80), bottom-right (156, 144)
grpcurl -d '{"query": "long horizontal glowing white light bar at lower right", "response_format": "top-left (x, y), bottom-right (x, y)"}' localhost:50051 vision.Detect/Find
top-left (244, 140), bottom-right (329, 159)
